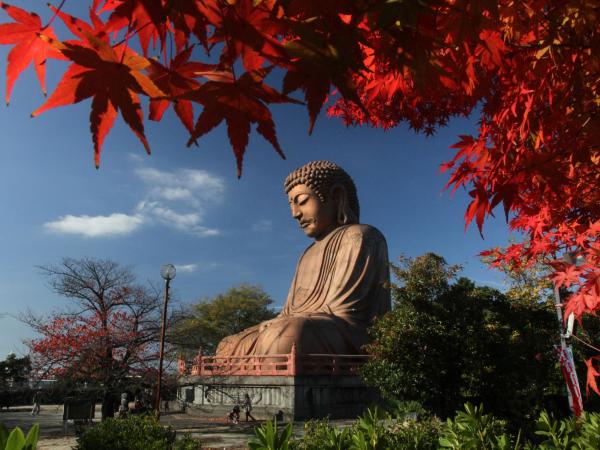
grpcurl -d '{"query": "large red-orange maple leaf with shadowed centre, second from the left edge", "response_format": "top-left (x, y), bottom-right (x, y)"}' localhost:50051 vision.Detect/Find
top-left (31, 35), bottom-right (165, 167)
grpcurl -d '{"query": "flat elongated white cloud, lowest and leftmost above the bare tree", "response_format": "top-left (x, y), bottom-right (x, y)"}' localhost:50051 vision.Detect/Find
top-left (44, 213), bottom-right (145, 237)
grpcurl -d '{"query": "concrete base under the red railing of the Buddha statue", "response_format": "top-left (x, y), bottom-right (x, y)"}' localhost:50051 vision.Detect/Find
top-left (178, 375), bottom-right (379, 421)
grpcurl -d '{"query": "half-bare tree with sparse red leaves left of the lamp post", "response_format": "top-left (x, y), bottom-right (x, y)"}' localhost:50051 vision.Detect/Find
top-left (22, 259), bottom-right (161, 418)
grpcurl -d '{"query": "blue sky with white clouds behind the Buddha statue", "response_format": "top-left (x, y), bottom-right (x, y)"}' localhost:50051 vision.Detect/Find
top-left (0, 1), bottom-right (508, 358)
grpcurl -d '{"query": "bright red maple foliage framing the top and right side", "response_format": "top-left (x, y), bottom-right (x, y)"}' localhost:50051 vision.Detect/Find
top-left (0, 0), bottom-right (600, 393)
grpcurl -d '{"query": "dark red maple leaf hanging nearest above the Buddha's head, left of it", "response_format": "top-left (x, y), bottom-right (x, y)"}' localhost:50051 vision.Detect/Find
top-left (184, 69), bottom-right (300, 178)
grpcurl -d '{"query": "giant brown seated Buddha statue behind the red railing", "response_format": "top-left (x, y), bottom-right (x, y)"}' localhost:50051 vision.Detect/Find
top-left (217, 161), bottom-right (390, 356)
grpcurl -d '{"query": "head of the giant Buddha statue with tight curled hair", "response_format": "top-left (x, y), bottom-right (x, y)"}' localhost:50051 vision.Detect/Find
top-left (284, 161), bottom-right (360, 240)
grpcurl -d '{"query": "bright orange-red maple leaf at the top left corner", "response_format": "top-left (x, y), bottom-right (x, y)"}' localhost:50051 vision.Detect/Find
top-left (0, 2), bottom-right (65, 105)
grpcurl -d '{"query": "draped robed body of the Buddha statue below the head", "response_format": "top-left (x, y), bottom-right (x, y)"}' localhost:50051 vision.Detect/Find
top-left (217, 224), bottom-right (390, 356)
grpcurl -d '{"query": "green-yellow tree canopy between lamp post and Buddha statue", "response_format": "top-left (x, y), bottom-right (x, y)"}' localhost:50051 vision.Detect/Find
top-left (169, 284), bottom-right (275, 354)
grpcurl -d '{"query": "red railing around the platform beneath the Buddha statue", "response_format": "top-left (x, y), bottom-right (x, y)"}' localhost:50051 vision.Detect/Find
top-left (179, 345), bottom-right (370, 376)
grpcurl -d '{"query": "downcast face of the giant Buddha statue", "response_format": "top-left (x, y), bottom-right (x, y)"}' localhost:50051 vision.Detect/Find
top-left (288, 184), bottom-right (338, 241)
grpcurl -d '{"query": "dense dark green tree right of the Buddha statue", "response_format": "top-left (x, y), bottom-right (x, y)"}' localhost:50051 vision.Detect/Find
top-left (362, 253), bottom-right (568, 425)
